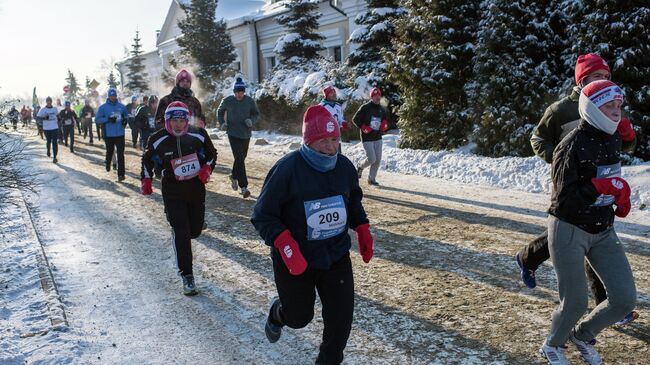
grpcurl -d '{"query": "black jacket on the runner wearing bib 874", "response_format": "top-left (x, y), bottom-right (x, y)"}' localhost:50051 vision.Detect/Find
top-left (140, 126), bottom-right (217, 200)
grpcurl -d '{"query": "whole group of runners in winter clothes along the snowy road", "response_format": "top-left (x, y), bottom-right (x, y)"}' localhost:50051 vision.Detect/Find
top-left (15, 54), bottom-right (639, 365)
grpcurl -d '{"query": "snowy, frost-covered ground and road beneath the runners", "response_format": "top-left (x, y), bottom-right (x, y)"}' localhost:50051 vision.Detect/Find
top-left (0, 126), bottom-right (650, 365)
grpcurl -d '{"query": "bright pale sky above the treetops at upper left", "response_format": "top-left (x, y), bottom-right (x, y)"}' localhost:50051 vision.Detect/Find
top-left (0, 0), bottom-right (172, 100)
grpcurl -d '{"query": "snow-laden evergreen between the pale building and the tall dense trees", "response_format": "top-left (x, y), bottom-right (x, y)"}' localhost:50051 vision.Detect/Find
top-left (347, 0), bottom-right (406, 105)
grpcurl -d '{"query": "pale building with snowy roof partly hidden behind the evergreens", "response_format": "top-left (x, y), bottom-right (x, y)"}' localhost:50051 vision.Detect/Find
top-left (117, 0), bottom-right (367, 91)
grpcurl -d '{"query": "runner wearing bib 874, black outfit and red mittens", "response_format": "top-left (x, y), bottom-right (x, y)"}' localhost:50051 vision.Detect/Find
top-left (140, 102), bottom-right (217, 295)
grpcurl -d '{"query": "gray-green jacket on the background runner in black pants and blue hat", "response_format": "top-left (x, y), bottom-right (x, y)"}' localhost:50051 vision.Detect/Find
top-left (217, 95), bottom-right (260, 139)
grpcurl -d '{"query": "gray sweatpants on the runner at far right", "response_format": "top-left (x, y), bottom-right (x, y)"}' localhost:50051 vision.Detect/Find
top-left (548, 215), bottom-right (636, 346)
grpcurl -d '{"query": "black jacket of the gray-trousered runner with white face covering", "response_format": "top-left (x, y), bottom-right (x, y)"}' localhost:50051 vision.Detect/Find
top-left (548, 121), bottom-right (621, 233)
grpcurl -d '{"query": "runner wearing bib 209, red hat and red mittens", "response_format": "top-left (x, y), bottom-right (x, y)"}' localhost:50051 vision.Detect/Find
top-left (251, 105), bottom-right (373, 364)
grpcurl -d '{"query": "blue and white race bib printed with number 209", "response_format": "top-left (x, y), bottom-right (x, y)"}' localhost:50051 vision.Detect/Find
top-left (304, 195), bottom-right (348, 241)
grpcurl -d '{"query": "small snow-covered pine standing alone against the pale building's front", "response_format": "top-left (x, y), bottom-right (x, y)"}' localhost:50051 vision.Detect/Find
top-left (274, 0), bottom-right (324, 67)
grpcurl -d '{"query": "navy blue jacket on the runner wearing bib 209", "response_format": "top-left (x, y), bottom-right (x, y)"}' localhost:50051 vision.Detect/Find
top-left (251, 151), bottom-right (368, 269)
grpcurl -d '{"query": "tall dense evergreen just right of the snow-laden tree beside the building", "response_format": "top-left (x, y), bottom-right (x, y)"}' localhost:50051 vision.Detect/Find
top-left (389, 0), bottom-right (479, 149)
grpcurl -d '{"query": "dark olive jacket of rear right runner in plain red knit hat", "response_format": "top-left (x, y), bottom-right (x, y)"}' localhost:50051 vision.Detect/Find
top-left (530, 88), bottom-right (636, 163)
